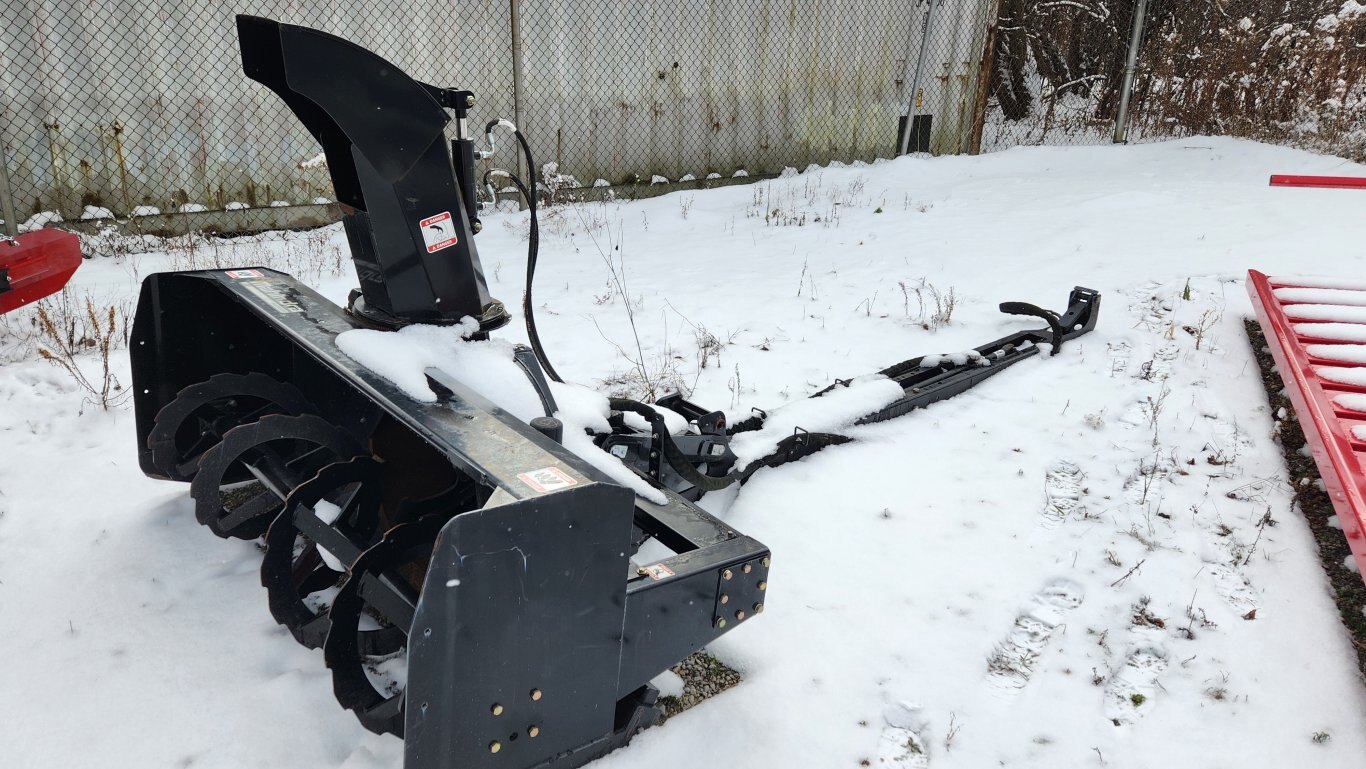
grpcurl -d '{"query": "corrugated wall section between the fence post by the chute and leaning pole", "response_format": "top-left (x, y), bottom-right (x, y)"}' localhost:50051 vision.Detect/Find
top-left (522, 0), bottom-right (910, 184)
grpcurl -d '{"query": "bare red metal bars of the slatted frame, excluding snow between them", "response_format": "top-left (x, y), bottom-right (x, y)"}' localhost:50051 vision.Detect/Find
top-left (1247, 269), bottom-right (1366, 581)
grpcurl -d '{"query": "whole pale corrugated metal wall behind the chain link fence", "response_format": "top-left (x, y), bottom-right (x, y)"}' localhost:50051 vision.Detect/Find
top-left (0, 0), bottom-right (986, 220)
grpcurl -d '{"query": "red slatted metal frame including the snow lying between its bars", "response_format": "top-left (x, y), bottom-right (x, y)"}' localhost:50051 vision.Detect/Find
top-left (1247, 270), bottom-right (1366, 579)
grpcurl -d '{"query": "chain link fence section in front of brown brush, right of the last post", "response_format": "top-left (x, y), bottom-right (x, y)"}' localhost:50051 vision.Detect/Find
top-left (1132, 0), bottom-right (1366, 155)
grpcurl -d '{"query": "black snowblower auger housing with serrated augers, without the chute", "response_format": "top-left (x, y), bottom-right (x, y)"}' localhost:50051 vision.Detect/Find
top-left (133, 269), bottom-right (769, 769)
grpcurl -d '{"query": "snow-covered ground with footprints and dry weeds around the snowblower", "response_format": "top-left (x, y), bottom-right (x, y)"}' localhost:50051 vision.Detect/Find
top-left (0, 138), bottom-right (1366, 769)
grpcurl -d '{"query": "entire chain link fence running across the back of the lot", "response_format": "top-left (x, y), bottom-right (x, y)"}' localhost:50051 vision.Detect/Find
top-left (0, 0), bottom-right (1366, 231)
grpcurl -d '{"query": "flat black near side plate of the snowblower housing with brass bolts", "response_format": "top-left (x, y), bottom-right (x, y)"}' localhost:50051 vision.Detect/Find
top-left (404, 484), bottom-right (632, 769)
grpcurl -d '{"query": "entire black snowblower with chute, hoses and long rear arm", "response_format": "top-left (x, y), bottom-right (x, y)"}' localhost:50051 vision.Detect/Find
top-left (131, 16), bottom-right (1100, 769)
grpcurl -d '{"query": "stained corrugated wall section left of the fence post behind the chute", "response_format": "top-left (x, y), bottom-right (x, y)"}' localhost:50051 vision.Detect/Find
top-left (0, 0), bottom-right (511, 224)
